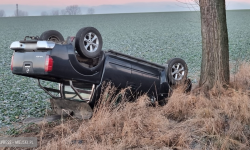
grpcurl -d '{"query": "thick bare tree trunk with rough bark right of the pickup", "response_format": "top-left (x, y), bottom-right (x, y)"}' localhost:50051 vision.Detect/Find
top-left (199, 0), bottom-right (230, 90)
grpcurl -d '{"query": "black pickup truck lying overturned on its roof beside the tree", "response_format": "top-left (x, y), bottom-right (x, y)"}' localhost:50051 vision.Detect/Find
top-left (10, 27), bottom-right (192, 118)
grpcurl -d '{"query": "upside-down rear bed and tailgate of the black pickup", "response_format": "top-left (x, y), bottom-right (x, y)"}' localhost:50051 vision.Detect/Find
top-left (12, 43), bottom-right (104, 83)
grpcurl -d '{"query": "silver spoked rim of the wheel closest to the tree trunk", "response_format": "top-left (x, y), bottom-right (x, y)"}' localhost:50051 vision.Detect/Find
top-left (171, 63), bottom-right (185, 81)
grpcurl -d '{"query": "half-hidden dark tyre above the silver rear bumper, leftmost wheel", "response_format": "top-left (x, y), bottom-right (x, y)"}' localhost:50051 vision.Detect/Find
top-left (39, 30), bottom-right (64, 43)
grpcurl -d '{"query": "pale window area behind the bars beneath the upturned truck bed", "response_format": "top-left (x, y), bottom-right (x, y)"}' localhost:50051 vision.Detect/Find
top-left (63, 85), bottom-right (92, 100)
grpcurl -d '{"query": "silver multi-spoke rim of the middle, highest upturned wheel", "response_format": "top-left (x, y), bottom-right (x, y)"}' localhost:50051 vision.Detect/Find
top-left (83, 32), bottom-right (99, 53)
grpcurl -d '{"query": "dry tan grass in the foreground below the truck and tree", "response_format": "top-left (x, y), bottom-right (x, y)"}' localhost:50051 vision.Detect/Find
top-left (12, 63), bottom-right (250, 150)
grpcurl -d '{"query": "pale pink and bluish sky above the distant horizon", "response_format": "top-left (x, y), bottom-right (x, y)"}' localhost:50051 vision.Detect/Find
top-left (0, 0), bottom-right (250, 16)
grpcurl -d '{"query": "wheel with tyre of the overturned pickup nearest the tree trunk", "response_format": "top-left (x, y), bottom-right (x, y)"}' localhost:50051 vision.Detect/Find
top-left (167, 58), bottom-right (188, 85)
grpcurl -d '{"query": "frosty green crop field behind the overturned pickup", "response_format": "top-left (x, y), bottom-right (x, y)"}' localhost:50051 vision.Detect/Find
top-left (0, 10), bottom-right (250, 127)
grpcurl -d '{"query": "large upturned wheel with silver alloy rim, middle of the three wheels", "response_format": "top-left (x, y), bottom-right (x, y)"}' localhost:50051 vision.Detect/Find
top-left (75, 27), bottom-right (102, 58)
